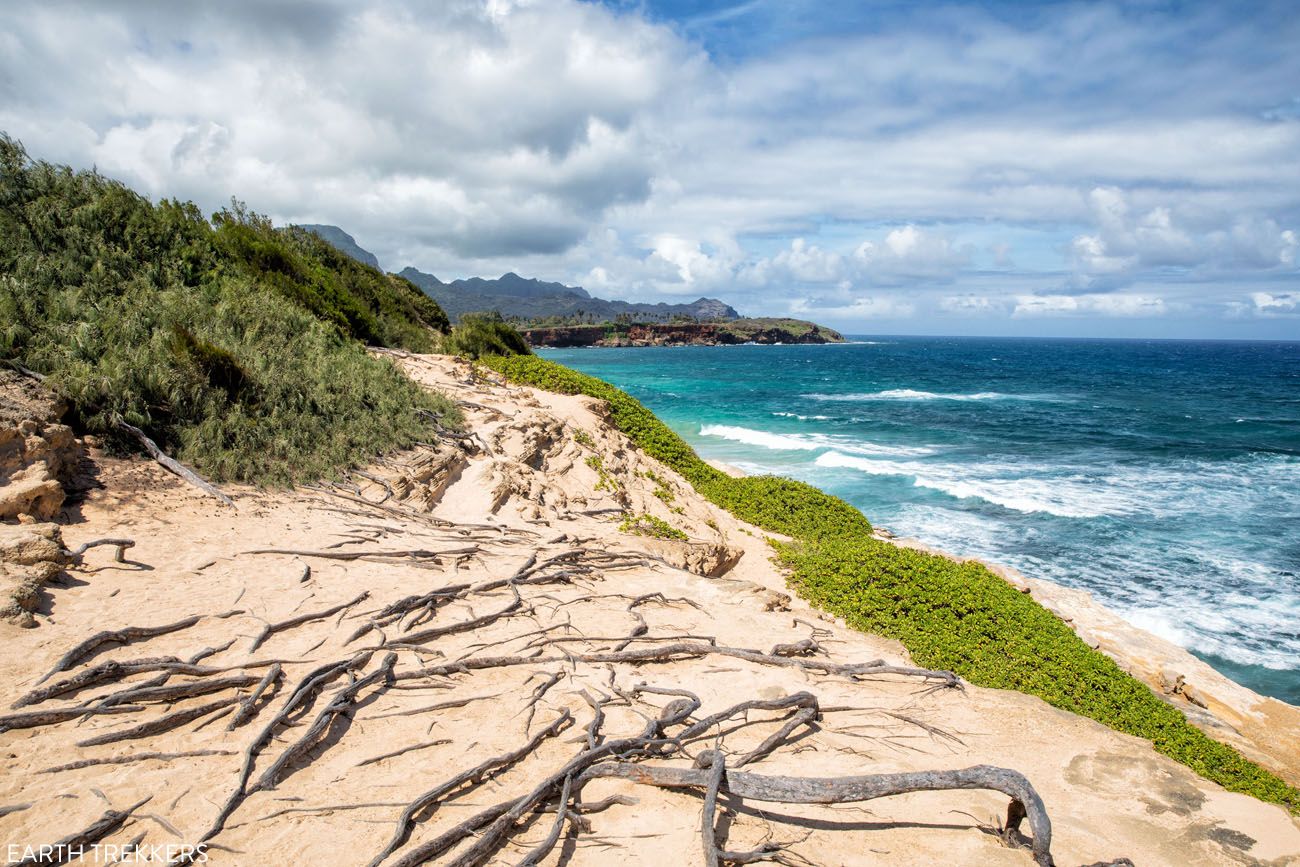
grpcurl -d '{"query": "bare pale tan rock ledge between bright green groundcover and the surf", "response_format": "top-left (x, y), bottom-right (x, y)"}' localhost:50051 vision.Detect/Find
top-left (712, 431), bottom-right (1300, 784)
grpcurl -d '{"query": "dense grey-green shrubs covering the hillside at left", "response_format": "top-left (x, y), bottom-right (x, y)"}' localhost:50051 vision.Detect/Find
top-left (0, 134), bottom-right (460, 484)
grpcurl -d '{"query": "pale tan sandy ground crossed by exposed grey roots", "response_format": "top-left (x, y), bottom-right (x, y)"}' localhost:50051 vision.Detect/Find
top-left (0, 357), bottom-right (1300, 867)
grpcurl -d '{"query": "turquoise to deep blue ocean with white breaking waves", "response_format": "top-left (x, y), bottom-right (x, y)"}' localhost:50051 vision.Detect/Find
top-left (542, 337), bottom-right (1300, 703)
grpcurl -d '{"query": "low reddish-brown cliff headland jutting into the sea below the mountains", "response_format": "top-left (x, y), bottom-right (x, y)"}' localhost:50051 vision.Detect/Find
top-left (520, 320), bottom-right (844, 347)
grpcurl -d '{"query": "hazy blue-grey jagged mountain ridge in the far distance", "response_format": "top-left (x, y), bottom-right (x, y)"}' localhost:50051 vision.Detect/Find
top-left (303, 225), bottom-right (740, 322)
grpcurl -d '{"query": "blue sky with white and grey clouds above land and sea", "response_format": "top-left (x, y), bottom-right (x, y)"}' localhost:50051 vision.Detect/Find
top-left (0, 0), bottom-right (1300, 339)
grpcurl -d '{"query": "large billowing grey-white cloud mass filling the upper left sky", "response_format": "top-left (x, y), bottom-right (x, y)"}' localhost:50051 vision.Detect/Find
top-left (0, 1), bottom-right (703, 259)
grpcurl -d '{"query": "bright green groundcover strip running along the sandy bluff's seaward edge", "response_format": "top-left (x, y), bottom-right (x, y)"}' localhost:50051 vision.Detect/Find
top-left (484, 356), bottom-right (1300, 812)
